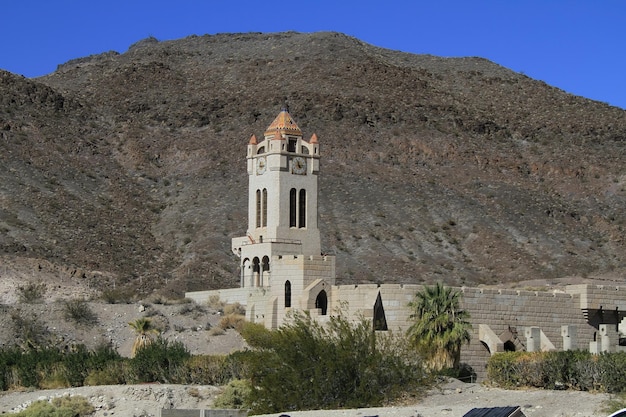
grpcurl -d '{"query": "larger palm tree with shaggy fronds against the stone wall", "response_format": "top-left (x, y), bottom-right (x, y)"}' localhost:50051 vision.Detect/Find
top-left (407, 283), bottom-right (472, 371)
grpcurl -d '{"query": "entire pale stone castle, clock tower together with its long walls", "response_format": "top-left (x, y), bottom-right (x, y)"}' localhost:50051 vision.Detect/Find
top-left (186, 110), bottom-right (626, 379)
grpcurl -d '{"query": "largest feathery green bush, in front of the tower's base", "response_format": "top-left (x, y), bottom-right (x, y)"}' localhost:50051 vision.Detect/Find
top-left (235, 308), bottom-right (425, 413)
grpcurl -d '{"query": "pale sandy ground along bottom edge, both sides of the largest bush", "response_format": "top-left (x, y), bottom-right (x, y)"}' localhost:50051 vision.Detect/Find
top-left (0, 380), bottom-right (610, 417)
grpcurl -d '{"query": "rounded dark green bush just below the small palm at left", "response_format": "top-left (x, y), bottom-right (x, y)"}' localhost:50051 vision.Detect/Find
top-left (129, 336), bottom-right (191, 383)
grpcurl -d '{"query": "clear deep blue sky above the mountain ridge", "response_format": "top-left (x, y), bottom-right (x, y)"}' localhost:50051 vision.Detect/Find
top-left (0, 0), bottom-right (626, 109)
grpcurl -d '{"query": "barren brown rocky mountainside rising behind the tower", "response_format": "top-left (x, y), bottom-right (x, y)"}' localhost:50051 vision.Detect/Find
top-left (0, 33), bottom-right (626, 294)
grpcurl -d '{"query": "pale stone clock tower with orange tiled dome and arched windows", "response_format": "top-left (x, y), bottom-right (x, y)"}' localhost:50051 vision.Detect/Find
top-left (232, 109), bottom-right (335, 328)
